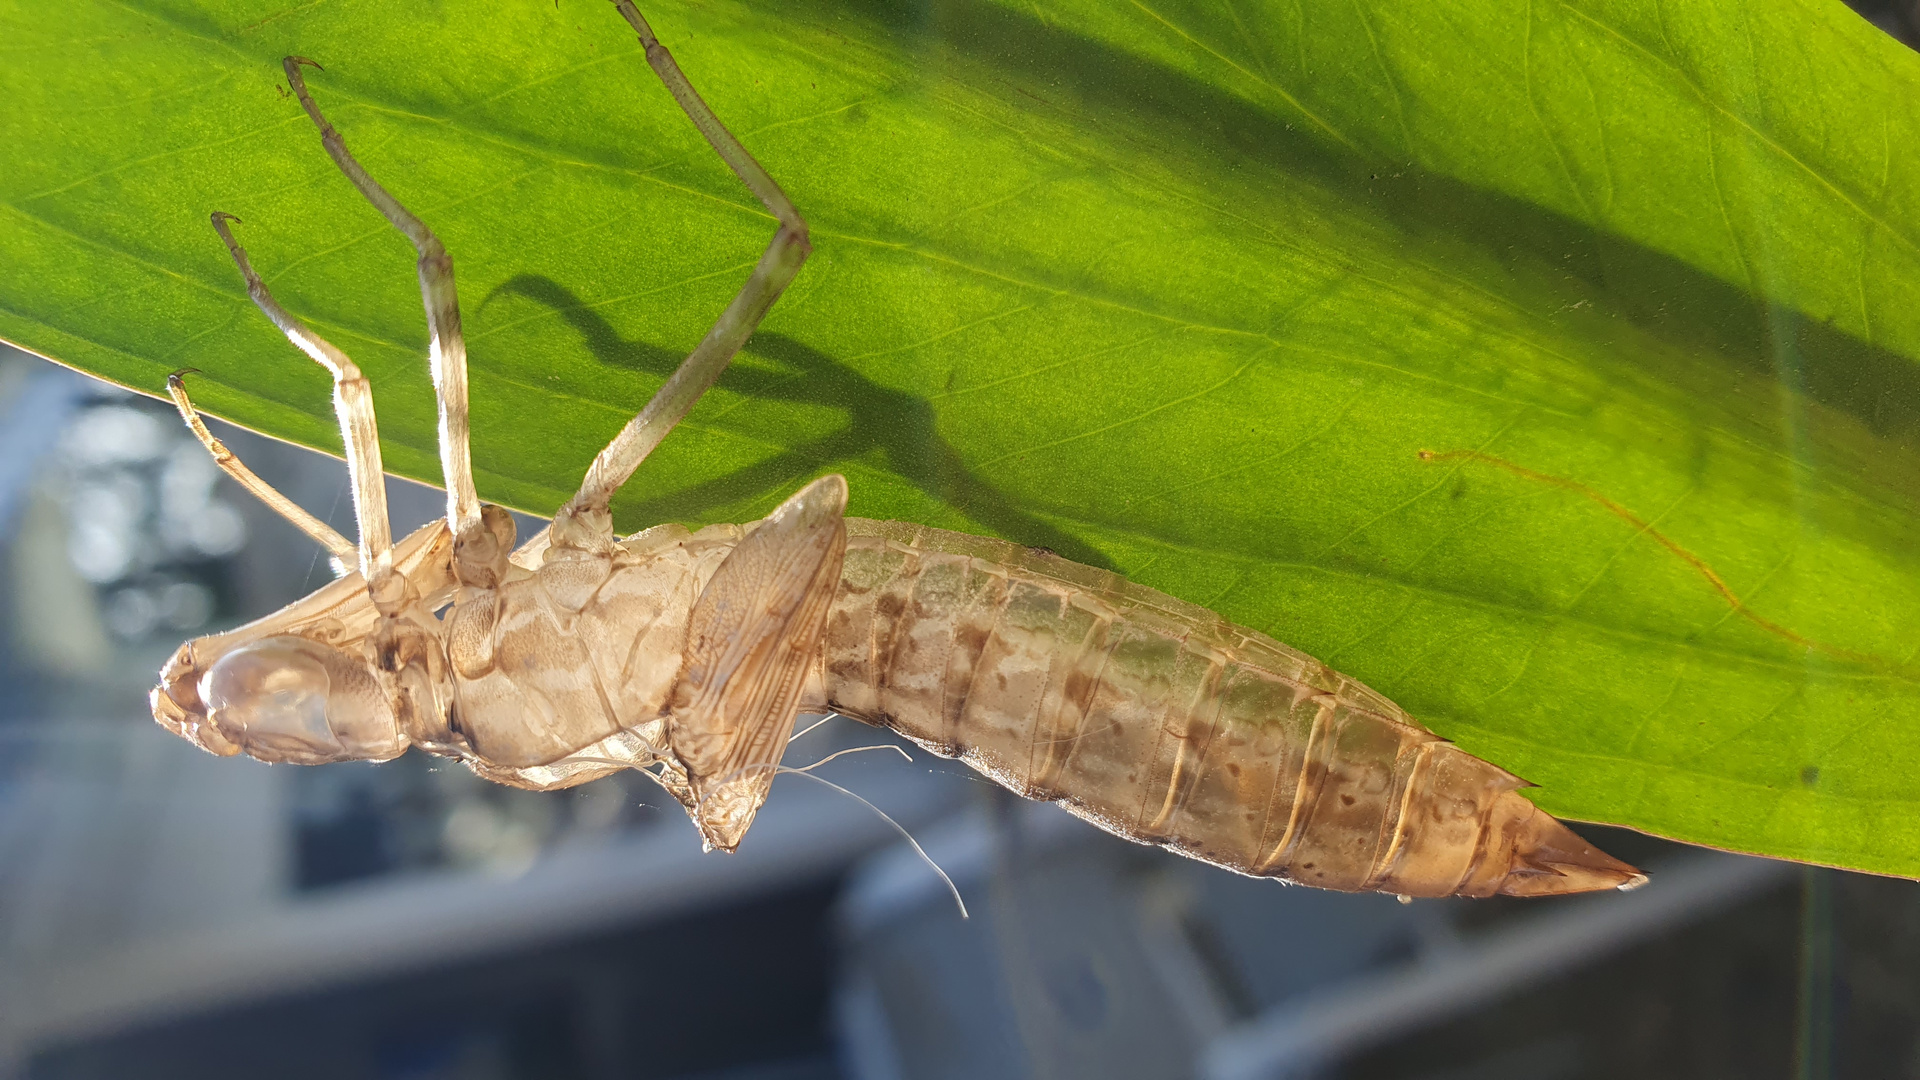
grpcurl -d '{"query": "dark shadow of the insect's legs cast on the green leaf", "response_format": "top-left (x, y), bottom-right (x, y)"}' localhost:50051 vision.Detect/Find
top-left (486, 275), bottom-right (1112, 569)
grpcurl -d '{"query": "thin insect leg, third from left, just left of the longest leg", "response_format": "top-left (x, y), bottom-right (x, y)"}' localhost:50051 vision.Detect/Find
top-left (280, 56), bottom-right (480, 540)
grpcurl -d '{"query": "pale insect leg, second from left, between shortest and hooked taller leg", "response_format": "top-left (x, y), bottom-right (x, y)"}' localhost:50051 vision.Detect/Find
top-left (213, 211), bottom-right (394, 588)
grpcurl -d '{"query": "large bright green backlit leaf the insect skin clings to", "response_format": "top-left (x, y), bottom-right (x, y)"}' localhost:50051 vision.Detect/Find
top-left (11, 0), bottom-right (1920, 874)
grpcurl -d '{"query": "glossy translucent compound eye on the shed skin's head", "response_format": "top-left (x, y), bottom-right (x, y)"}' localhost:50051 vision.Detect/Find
top-left (200, 636), bottom-right (405, 765)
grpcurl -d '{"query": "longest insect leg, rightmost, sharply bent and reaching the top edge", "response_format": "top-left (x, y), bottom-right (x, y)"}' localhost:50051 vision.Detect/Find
top-left (561, 0), bottom-right (812, 517)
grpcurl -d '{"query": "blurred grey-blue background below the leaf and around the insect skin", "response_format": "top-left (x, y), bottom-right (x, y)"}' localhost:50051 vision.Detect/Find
top-left (0, 319), bottom-right (1920, 1080)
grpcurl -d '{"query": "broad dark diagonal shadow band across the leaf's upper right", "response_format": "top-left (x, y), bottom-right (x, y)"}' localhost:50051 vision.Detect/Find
top-left (766, 0), bottom-right (1920, 492)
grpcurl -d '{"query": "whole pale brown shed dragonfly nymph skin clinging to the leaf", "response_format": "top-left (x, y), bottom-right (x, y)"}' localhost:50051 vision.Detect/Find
top-left (152, 0), bottom-right (1645, 896)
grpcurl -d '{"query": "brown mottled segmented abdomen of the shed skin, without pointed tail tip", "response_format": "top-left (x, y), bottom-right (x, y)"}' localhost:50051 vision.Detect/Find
top-left (822, 519), bottom-right (1532, 896)
